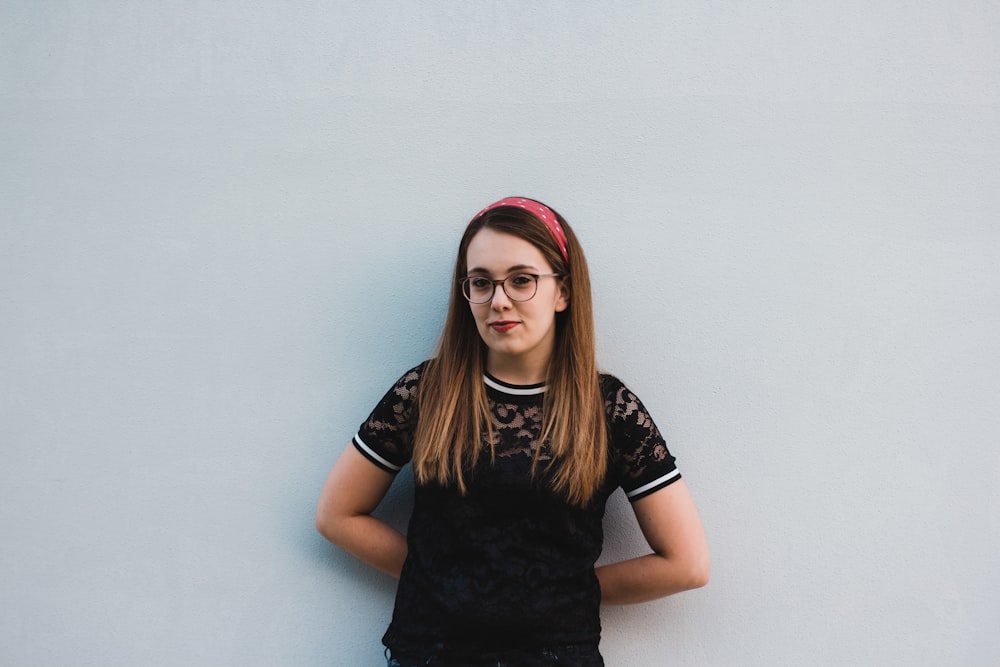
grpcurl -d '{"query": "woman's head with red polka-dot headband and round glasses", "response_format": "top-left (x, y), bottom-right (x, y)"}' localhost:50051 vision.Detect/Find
top-left (442, 198), bottom-right (594, 378)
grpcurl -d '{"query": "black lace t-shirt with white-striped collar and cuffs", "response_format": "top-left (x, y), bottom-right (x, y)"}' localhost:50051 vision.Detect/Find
top-left (354, 365), bottom-right (680, 656)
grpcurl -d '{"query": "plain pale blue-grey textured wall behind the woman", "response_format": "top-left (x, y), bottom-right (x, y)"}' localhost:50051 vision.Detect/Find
top-left (0, 0), bottom-right (1000, 667)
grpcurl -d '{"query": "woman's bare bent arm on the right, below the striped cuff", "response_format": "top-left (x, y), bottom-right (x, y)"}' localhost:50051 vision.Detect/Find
top-left (597, 480), bottom-right (709, 604)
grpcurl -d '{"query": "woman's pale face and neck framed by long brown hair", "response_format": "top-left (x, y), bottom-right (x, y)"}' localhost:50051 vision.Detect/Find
top-left (465, 228), bottom-right (569, 382)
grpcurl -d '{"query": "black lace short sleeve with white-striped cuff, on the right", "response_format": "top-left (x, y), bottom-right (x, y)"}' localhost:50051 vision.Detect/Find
top-left (601, 375), bottom-right (681, 501)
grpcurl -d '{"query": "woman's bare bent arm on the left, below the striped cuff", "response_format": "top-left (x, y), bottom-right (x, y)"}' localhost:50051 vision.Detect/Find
top-left (316, 444), bottom-right (406, 579)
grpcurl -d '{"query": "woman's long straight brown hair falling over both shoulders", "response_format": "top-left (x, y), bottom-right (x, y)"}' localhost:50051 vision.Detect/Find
top-left (413, 198), bottom-right (608, 506)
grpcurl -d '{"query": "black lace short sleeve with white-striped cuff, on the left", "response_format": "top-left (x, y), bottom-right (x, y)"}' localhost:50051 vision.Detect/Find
top-left (353, 364), bottom-right (423, 474)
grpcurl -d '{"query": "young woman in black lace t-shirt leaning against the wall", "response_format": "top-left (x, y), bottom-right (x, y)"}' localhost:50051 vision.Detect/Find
top-left (316, 197), bottom-right (709, 667)
